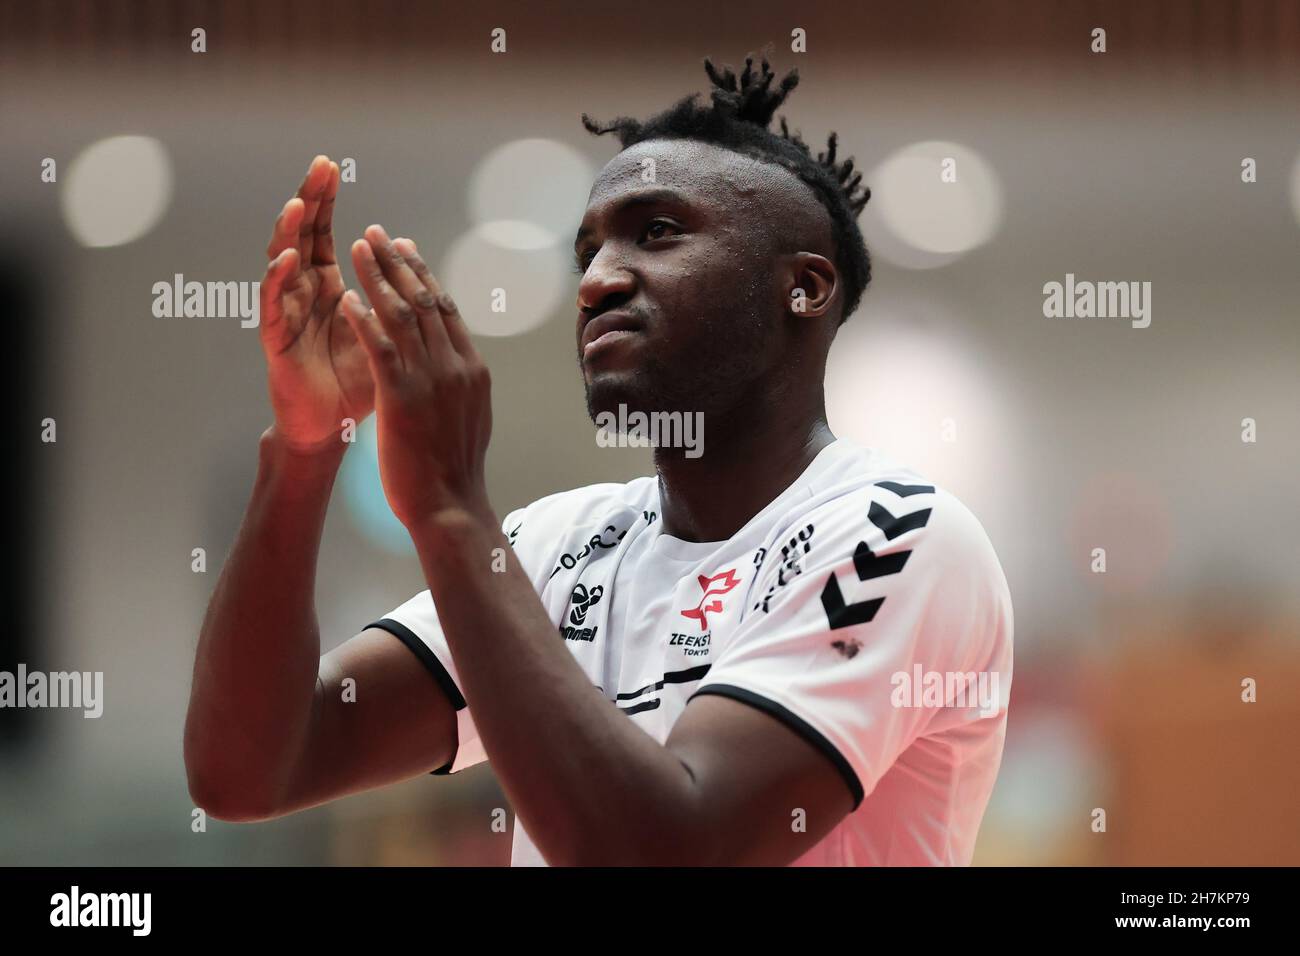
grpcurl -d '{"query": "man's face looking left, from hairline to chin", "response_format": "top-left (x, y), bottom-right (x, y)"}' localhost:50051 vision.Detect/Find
top-left (575, 140), bottom-right (789, 420)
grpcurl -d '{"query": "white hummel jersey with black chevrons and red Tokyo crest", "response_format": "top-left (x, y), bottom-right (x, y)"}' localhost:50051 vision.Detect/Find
top-left (371, 438), bottom-right (1013, 866)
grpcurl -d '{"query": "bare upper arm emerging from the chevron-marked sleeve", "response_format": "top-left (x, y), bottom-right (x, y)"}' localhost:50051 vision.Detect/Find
top-left (664, 695), bottom-right (853, 866)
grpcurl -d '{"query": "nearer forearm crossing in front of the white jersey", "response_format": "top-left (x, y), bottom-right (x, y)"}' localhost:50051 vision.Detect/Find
top-left (412, 515), bottom-right (707, 865)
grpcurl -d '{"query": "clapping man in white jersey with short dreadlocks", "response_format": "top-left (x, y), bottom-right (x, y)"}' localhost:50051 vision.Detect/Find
top-left (186, 60), bottom-right (1011, 865)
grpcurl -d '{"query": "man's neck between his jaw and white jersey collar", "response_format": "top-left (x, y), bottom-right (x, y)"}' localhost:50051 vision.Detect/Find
top-left (655, 393), bottom-right (835, 541)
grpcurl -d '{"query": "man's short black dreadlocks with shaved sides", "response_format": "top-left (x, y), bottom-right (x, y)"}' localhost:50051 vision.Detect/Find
top-left (582, 56), bottom-right (871, 323)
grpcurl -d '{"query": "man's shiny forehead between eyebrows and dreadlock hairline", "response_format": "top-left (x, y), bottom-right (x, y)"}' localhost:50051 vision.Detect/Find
top-left (584, 139), bottom-right (802, 221)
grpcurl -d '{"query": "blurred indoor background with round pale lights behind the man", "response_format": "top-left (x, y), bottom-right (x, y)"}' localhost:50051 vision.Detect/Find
top-left (0, 0), bottom-right (1300, 865)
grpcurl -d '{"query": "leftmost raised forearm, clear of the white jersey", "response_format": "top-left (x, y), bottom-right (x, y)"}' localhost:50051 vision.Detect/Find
top-left (185, 429), bottom-right (345, 814)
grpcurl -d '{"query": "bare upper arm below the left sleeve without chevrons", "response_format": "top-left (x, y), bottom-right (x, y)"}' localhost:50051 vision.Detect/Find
top-left (274, 627), bottom-right (456, 813)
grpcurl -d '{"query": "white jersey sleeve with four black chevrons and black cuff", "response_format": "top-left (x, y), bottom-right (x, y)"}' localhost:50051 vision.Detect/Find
top-left (692, 483), bottom-right (1011, 810)
